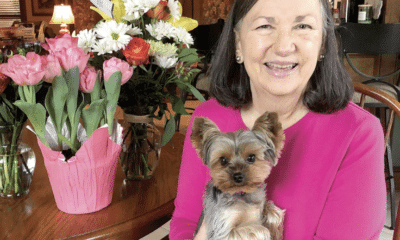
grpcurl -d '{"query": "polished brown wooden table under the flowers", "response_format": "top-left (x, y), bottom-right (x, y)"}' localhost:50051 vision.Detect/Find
top-left (0, 126), bottom-right (184, 240)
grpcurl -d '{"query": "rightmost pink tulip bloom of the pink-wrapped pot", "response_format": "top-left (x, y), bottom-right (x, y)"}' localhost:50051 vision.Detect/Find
top-left (103, 57), bottom-right (133, 85)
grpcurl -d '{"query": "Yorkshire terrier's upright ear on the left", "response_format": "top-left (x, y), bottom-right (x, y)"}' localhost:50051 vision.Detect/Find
top-left (190, 117), bottom-right (220, 165)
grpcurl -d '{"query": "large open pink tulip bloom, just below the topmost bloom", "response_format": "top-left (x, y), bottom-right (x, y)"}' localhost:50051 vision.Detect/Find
top-left (53, 47), bottom-right (90, 73)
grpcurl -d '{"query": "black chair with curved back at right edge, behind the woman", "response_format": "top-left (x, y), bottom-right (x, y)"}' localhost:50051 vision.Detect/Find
top-left (337, 23), bottom-right (400, 229)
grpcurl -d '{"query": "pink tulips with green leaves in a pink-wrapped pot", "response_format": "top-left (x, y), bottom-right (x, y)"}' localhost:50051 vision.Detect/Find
top-left (0, 34), bottom-right (133, 213)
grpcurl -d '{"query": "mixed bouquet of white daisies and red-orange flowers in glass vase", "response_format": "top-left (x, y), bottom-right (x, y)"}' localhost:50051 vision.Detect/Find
top-left (77, 0), bottom-right (204, 179)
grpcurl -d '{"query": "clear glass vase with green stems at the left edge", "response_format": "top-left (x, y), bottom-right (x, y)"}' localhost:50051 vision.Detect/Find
top-left (0, 124), bottom-right (36, 198)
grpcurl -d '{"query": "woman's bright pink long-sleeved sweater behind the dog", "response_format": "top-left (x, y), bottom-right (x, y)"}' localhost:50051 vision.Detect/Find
top-left (169, 99), bottom-right (386, 240)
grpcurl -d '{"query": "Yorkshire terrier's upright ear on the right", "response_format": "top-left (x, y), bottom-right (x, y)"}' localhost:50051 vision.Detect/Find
top-left (251, 112), bottom-right (285, 164)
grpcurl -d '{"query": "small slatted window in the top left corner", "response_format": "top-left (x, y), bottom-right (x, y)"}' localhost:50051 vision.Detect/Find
top-left (0, 0), bottom-right (23, 27)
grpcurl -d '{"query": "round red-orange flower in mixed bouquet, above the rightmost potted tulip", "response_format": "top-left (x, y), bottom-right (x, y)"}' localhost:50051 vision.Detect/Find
top-left (122, 37), bottom-right (150, 66)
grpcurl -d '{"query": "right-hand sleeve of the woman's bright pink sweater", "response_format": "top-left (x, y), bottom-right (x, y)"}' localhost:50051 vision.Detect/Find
top-left (314, 114), bottom-right (386, 240)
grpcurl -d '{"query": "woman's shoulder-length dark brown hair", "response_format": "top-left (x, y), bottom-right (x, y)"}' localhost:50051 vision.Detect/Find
top-left (208, 0), bottom-right (353, 113)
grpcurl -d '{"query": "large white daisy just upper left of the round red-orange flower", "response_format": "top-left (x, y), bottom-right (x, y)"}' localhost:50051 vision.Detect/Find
top-left (95, 20), bottom-right (132, 51)
